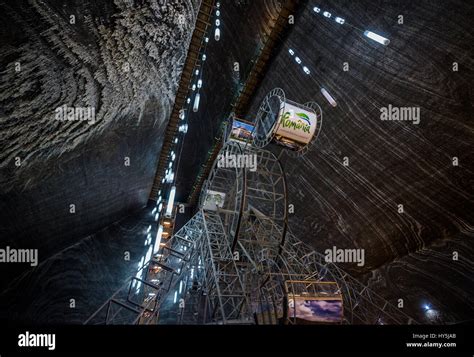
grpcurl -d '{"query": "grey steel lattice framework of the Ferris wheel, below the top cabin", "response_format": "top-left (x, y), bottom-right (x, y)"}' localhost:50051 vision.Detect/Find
top-left (86, 126), bottom-right (416, 324)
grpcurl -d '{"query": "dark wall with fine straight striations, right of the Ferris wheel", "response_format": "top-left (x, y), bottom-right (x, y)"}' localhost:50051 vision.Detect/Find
top-left (246, 0), bottom-right (474, 321)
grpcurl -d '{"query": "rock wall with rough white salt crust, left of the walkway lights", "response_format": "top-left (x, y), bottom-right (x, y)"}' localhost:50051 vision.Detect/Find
top-left (0, 0), bottom-right (199, 259)
